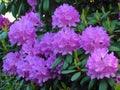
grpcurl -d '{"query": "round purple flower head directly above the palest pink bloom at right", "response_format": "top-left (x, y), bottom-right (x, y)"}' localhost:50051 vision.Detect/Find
top-left (81, 26), bottom-right (110, 53)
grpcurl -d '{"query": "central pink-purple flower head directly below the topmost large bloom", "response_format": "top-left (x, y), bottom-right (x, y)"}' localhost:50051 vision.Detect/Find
top-left (52, 27), bottom-right (81, 55)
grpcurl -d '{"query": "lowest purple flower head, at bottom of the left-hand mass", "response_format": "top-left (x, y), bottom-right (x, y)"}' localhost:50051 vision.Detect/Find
top-left (17, 55), bottom-right (51, 85)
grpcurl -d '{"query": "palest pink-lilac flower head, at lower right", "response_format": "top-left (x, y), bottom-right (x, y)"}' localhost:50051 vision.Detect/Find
top-left (86, 49), bottom-right (118, 79)
